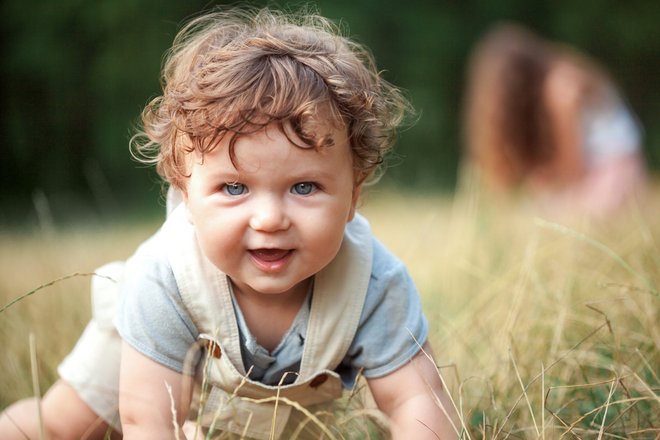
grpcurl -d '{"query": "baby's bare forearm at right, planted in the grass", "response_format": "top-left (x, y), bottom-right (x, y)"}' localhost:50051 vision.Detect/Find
top-left (368, 344), bottom-right (460, 440)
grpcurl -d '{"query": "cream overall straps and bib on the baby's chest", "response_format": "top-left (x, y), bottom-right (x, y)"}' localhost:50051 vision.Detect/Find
top-left (165, 206), bottom-right (372, 439)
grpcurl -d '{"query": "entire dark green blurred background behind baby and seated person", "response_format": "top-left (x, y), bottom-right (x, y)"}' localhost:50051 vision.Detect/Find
top-left (0, 0), bottom-right (660, 227)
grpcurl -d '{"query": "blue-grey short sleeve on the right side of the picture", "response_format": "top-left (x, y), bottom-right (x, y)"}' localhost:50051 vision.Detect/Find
top-left (338, 241), bottom-right (428, 387)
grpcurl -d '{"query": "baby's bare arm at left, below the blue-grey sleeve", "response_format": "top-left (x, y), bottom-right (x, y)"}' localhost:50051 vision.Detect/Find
top-left (119, 342), bottom-right (192, 440)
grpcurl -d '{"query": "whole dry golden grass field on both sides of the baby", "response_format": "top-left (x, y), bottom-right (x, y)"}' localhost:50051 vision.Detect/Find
top-left (0, 178), bottom-right (660, 439)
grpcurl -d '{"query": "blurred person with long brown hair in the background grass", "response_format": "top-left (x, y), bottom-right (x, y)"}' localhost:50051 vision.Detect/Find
top-left (463, 24), bottom-right (645, 217)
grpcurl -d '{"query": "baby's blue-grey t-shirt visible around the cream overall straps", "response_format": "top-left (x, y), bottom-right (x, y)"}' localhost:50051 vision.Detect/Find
top-left (115, 223), bottom-right (428, 388)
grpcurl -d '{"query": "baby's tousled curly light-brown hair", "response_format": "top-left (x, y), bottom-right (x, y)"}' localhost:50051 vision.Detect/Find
top-left (131, 7), bottom-right (412, 189)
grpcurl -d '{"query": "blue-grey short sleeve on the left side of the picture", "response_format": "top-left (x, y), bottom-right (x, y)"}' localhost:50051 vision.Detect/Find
top-left (114, 238), bottom-right (198, 373)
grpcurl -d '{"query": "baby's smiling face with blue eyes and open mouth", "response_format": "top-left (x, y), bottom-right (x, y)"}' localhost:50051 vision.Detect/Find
top-left (184, 125), bottom-right (359, 295)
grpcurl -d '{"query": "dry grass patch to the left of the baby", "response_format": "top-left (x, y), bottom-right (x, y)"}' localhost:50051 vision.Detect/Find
top-left (0, 225), bottom-right (155, 407)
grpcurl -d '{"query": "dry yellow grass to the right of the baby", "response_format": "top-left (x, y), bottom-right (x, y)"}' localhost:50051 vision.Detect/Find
top-left (366, 176), bottom-right (660, 439)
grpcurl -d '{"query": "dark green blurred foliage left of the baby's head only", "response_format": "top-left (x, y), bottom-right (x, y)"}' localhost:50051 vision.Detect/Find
top-left (0, 0), bottom-right (209, 220)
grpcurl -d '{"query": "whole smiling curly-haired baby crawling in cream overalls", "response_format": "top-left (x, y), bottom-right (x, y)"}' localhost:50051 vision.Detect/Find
top-left (0, 4), bottom-right (458, 439)
